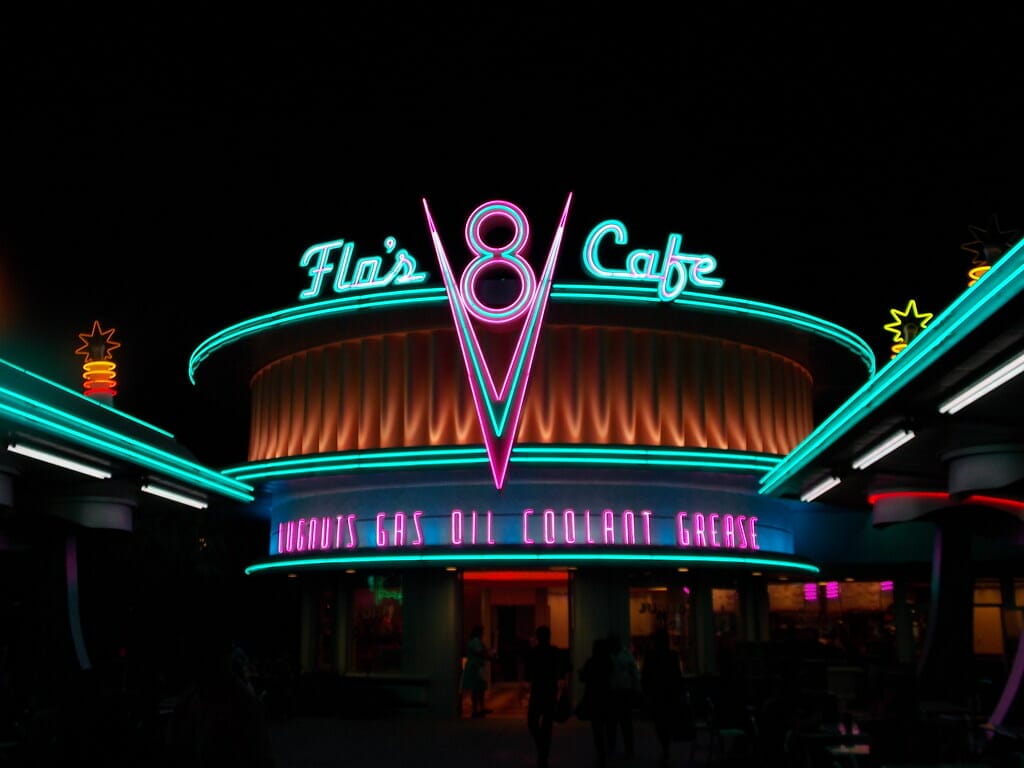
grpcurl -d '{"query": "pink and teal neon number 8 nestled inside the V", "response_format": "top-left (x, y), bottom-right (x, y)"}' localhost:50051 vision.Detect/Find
top-left (459, 201), bottom-right (537, 325)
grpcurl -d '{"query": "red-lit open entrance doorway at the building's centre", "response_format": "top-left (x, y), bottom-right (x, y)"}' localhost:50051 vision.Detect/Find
top-left (462, 570), bottom-right (570, 717)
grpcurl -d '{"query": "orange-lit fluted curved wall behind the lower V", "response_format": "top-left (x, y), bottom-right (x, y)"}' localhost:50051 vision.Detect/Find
top-left (243, 325), bottom-right (813, 461)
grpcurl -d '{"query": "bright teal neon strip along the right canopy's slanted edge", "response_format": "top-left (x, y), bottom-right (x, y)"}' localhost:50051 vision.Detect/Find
top-left (759, 241), bottom-right (1024, 495)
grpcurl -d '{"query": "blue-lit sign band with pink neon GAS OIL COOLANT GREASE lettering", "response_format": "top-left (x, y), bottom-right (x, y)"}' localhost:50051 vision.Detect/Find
top-left (270, 507), bottom-right (761, 555)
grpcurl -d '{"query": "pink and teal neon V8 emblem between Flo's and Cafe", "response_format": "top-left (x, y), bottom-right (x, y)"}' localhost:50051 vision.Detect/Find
top-left (423, 193), bottom-right (572, 489)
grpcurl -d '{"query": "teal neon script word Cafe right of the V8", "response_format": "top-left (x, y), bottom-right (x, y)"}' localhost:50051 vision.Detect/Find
top-left (583, 219), bottom-right (725, 301)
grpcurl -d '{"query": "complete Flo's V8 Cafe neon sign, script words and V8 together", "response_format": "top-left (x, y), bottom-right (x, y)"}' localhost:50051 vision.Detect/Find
top-left (299, 193), bottom-right (724, 489)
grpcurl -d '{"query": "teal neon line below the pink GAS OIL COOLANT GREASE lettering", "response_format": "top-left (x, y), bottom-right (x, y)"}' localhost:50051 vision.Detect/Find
top-left (246, 551), bottom-right (819, 574)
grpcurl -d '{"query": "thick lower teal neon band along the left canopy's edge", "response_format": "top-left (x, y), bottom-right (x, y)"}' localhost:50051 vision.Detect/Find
top-left (0, 387), bottom-right (254, 502)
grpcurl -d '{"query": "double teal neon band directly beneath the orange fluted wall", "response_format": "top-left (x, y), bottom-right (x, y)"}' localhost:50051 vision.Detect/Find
top-left (223, 444), bottom-right (781, 481)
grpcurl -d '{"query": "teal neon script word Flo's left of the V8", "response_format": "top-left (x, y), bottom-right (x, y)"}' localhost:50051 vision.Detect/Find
top-left (299, 237), bottom-right (428, 301)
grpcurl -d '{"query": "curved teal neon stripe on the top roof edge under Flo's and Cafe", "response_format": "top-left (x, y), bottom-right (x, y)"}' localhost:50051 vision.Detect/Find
top-left (188, 284), bottom-right (868, 384)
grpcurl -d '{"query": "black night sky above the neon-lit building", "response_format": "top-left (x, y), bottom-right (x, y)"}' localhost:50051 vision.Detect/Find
top-left (0, 3), bottom-right (1024, 466)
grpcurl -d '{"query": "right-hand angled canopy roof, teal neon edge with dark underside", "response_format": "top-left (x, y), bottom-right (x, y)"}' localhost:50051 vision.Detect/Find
top-left (760, 241), bottom-right (1024, 507)
